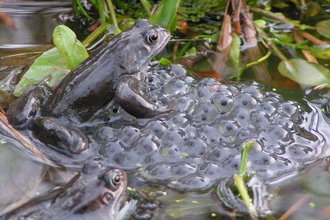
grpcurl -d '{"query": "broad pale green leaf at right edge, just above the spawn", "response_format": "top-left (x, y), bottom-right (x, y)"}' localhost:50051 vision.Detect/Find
top-left (278, 59), bottom-right (330, 88)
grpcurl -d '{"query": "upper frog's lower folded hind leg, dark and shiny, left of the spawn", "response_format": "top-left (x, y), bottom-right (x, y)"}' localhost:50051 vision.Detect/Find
top-left (29, 117), bottom-right (88, 155)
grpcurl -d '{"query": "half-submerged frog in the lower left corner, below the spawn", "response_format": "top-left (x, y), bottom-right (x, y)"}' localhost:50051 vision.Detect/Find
top-left (0, 162), bottom-right (127, 219)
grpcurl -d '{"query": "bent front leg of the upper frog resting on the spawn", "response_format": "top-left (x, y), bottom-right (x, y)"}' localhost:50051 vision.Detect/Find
top-left (115, 76), bottom-right (172, 118)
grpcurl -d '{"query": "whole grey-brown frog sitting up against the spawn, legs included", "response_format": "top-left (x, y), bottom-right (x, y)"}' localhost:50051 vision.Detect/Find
top-left (7, 19), bottom-right (171, 154)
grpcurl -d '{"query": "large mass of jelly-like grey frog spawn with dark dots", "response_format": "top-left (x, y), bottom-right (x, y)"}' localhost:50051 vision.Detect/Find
top-left (95, 65), bottom-right (325, 190)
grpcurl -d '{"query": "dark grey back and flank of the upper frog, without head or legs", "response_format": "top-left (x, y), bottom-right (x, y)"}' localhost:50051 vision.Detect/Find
top-left (47, 34), bottom-right (135, 121)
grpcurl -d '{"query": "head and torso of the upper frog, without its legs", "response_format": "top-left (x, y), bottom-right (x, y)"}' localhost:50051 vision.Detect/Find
top-left (42, 19), bottom-right (170, 122)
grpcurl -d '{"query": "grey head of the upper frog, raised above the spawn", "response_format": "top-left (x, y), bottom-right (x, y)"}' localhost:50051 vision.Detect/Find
top-left (121, 19), bottom-right (170, 67)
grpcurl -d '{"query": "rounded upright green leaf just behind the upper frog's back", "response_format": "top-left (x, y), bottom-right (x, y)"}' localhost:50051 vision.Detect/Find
top-left (53, 25), bottom-right (88, 70)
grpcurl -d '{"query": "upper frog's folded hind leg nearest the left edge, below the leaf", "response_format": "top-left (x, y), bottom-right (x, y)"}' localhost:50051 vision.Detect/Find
top-left (6, 85), bottom-right (52, 129)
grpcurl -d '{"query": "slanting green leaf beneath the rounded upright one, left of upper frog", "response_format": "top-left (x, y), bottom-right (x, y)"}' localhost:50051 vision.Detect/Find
top-left (14, 48), bottom-right (68, 96)
